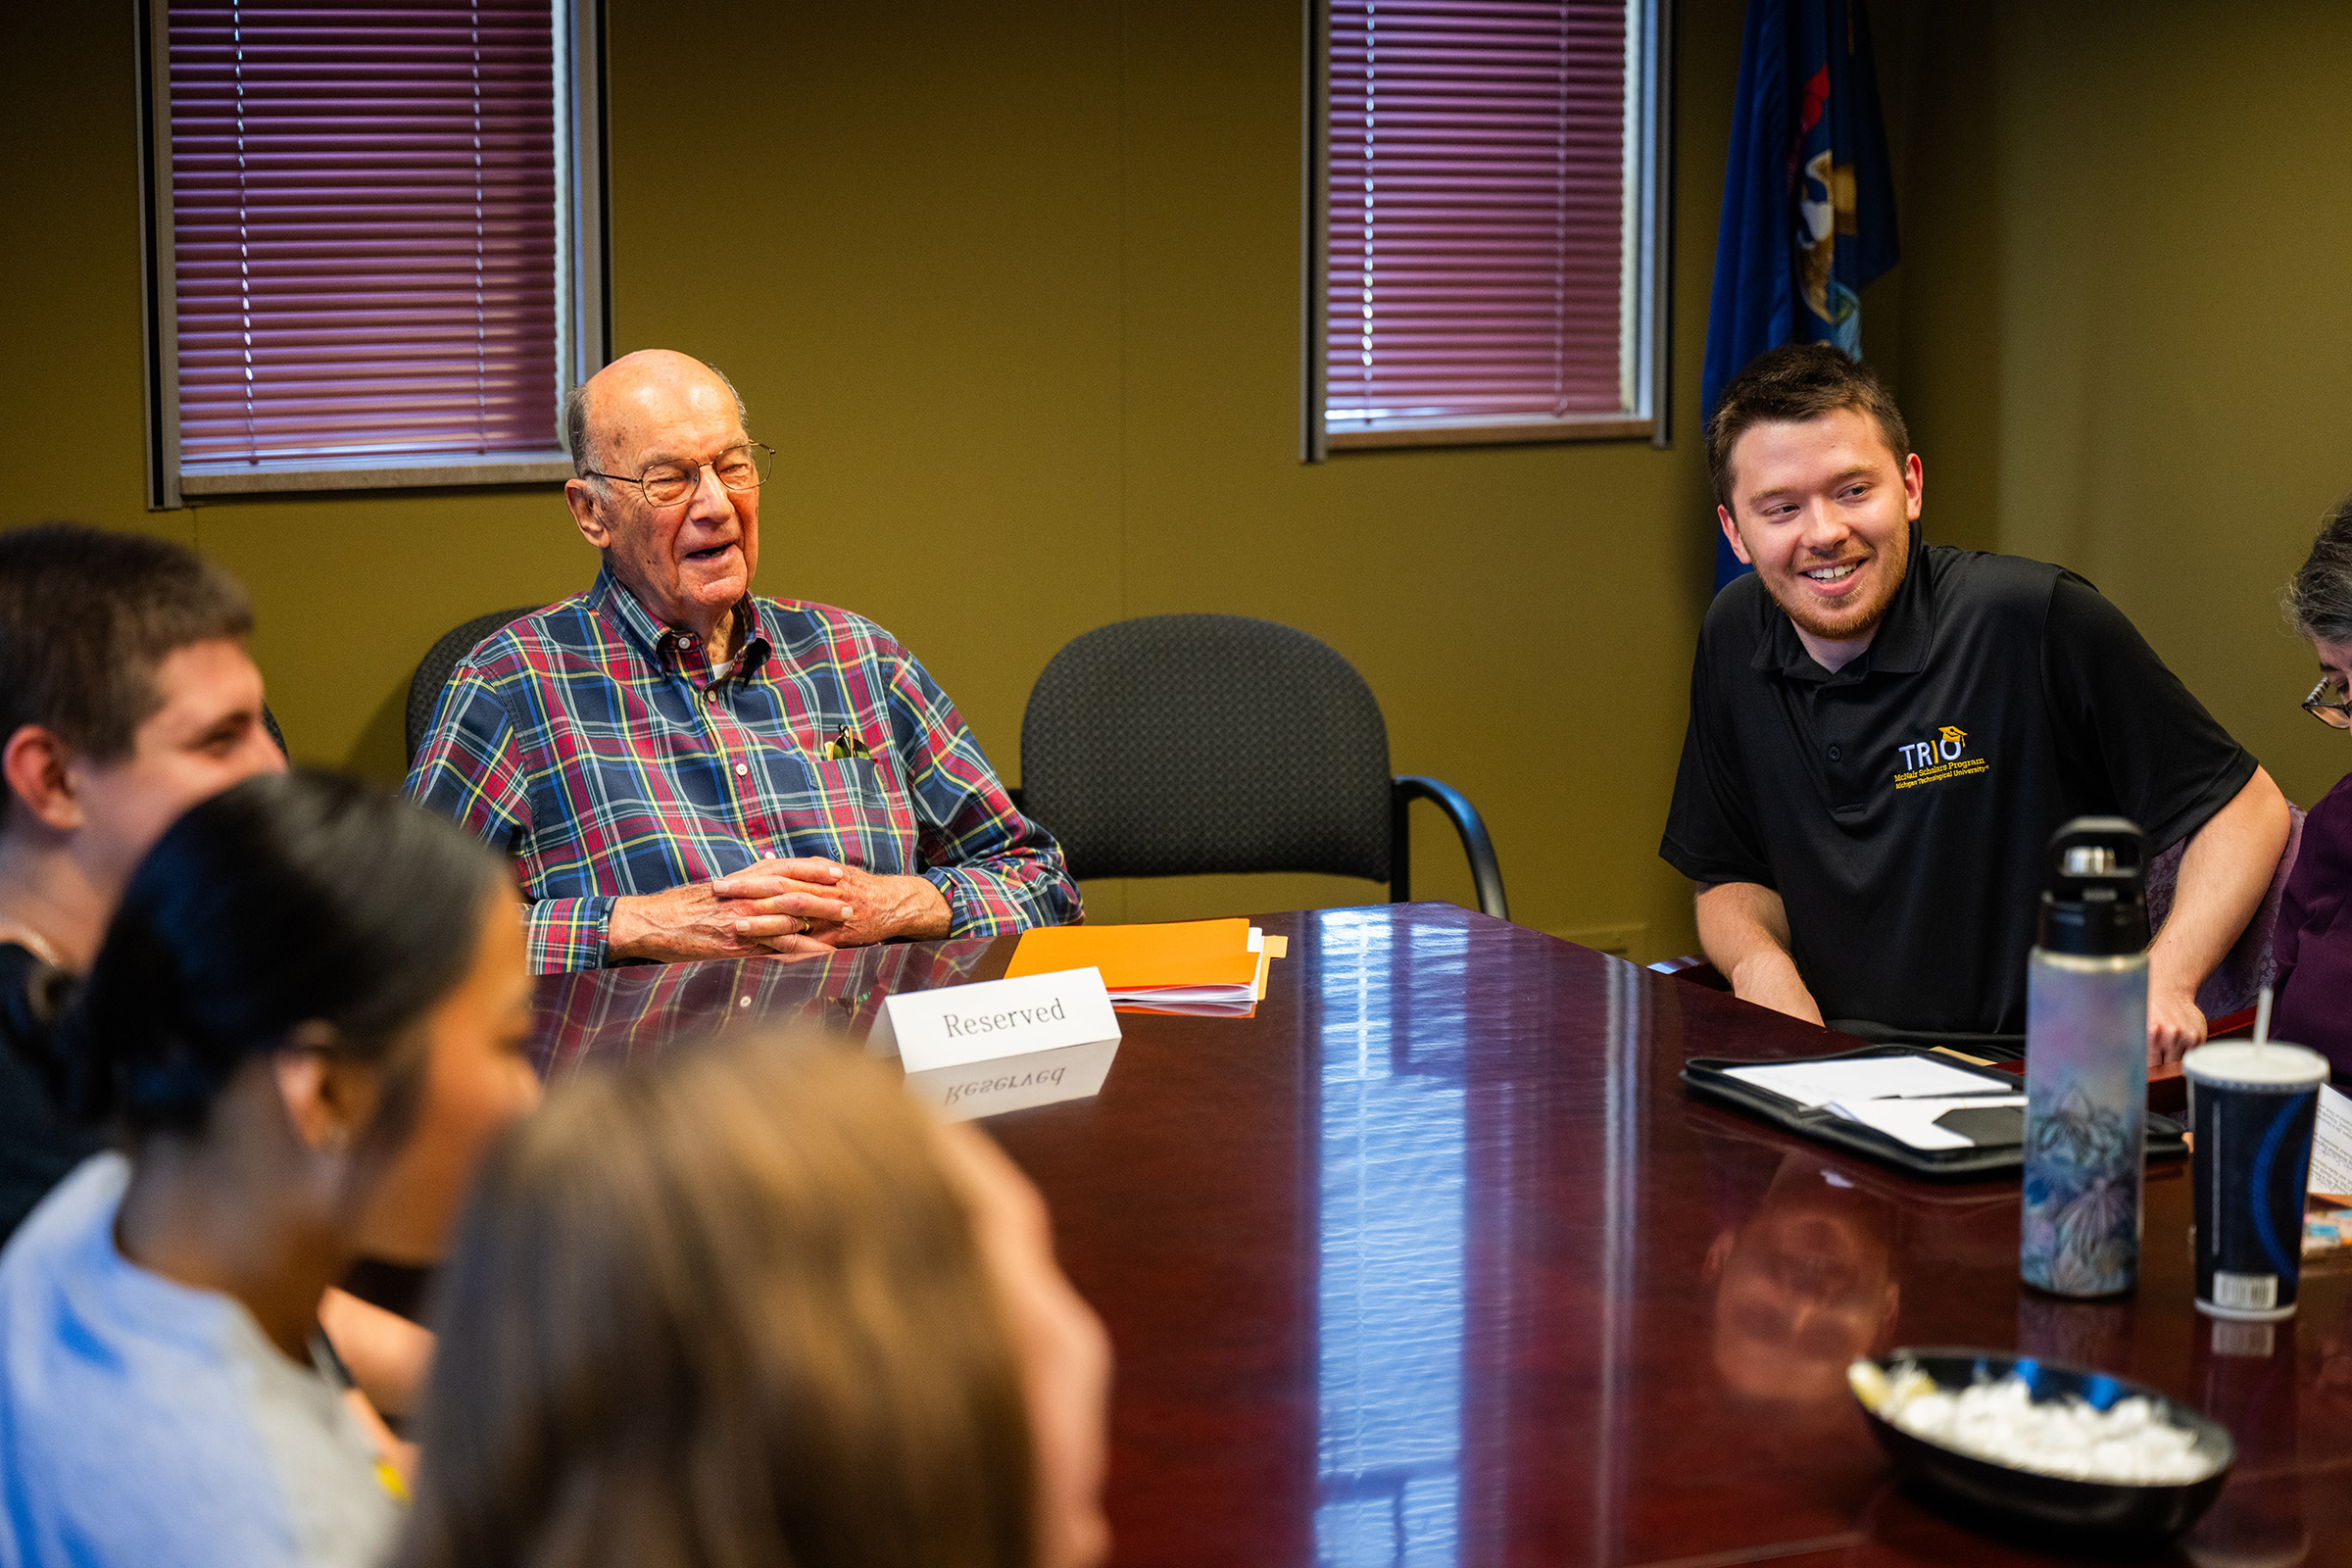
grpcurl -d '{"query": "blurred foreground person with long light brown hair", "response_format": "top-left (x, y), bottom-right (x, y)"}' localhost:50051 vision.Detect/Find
top-left (395, 1034), bottom-right (1110, 1568)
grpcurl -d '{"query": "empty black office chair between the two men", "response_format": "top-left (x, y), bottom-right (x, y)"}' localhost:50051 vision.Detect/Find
top-left (1021, 615), bottom-right (1510, 919)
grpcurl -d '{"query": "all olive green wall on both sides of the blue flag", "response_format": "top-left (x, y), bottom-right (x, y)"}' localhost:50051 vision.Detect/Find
top-left (14, 0), bottom-right (2352, 956)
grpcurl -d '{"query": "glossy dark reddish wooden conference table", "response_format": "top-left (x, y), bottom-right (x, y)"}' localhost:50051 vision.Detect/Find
top-left (539, 906), bottom-right (2352, 1568)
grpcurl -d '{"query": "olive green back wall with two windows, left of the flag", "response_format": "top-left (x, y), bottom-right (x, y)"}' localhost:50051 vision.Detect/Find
top-left (0, 0), bottom-right (1740, 956)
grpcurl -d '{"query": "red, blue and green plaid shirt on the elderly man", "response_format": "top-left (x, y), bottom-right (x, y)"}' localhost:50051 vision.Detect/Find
top-left (407, 571), bottom-right (1082, 973)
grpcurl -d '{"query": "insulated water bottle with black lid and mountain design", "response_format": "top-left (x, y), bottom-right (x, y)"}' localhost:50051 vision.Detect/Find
top-left (2018, 815), bottom-right (2147, 1296)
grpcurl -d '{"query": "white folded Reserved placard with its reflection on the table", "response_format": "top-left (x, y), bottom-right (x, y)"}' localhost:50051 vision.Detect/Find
top-left (865, 968), bottom-right (1119, 1121)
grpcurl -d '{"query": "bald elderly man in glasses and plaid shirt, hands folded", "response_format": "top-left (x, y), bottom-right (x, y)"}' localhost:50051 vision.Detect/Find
top-left (407, 350), bottom-right (1082, 973)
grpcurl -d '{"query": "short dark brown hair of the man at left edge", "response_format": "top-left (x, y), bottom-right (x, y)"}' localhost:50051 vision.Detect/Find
top-left (0, 522), bottom-right (254, 770)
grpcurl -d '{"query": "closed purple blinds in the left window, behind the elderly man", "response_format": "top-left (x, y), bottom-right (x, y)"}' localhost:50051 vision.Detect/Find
top-left (170, 0), bottom-right (560, 472)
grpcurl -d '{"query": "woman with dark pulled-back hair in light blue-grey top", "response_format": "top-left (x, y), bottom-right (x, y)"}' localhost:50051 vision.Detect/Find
top-left (0, 773), bottom-right (536, 1568)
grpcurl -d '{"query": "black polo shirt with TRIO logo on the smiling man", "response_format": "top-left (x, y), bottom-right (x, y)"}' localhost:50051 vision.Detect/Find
top-left (1658, 524), bottom-right (2256, 1034)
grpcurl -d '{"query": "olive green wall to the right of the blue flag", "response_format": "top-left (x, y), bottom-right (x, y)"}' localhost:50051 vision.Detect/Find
top-left (1882, 0), bottom-right (2352, 822)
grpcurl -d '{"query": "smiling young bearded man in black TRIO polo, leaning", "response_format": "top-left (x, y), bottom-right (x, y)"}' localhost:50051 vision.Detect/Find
top-left (1658, 343), bottom-right (2288, 1062)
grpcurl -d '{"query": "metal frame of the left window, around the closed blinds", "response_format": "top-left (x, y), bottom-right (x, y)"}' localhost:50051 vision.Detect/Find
top-left (136, 0), bottom-right (612, 513)
